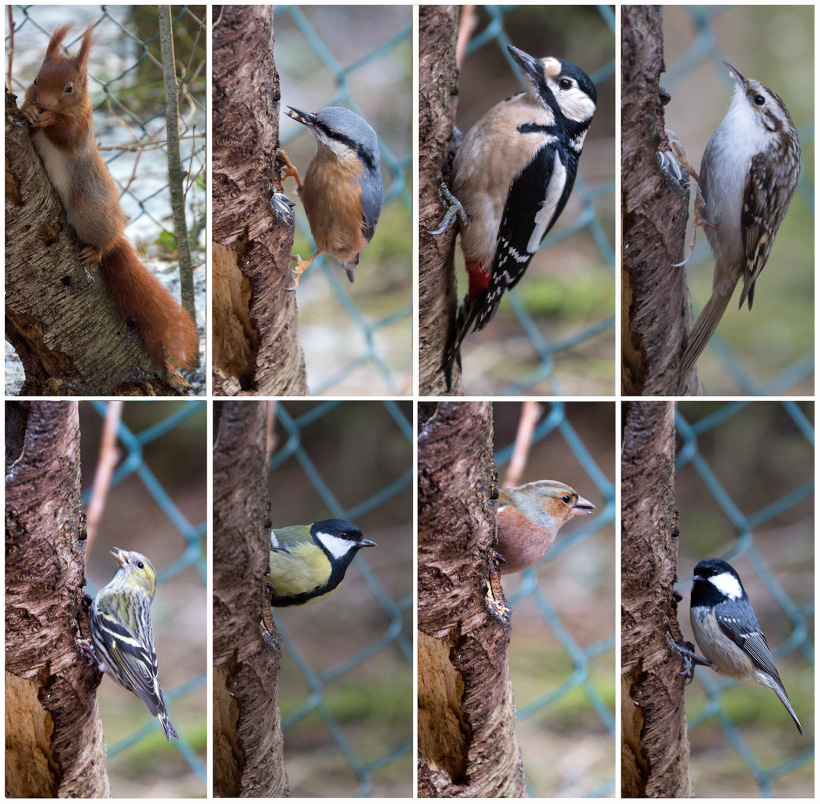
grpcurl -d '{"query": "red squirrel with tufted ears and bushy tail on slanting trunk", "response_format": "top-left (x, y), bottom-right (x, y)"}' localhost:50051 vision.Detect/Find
top-left (20, 23), bottom-right (199, 371)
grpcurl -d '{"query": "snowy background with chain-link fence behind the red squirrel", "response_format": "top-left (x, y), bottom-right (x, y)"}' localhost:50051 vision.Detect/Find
top-left (5, 5), bottom-right (208, 395)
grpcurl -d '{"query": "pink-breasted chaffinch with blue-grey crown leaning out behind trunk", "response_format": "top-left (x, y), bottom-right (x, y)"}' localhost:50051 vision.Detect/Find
top-left (496, 480), bottom-right (595, 575)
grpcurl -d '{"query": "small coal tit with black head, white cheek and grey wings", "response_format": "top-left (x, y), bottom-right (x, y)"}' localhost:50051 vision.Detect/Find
top-left (671, 558), bottom-right (803, 734)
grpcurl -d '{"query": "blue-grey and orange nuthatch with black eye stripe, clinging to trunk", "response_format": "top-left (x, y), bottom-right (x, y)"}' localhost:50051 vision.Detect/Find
top-left (280, 106), bottom-right (384, 290)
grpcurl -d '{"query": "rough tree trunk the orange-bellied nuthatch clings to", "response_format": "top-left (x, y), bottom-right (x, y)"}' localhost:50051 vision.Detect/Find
top-left (211, 6), bottom-right (308, 396)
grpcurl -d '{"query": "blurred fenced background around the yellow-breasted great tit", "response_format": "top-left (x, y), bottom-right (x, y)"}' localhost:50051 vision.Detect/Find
top-left (269, 401), bottom-right (415, 798)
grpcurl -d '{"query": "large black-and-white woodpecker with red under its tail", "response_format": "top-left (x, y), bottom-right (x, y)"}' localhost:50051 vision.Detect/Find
top-left (431, 45), bottom-right (597, 386)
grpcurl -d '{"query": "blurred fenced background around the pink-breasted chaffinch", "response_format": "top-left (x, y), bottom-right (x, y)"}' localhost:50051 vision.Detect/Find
top-left (493, 402), bottom-right (617, 798)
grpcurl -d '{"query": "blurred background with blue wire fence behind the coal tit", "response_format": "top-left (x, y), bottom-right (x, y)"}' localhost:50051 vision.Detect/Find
top-left (675, 402), bottom-right (814, 798)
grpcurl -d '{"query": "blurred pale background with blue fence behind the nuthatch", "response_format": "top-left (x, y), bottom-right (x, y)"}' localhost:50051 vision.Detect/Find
top-left (274, 5), bottom-right (413, 396)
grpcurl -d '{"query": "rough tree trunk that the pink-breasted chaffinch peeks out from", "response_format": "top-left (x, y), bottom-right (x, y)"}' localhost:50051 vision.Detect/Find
top-left (418, 402), bottom-right (525, 798)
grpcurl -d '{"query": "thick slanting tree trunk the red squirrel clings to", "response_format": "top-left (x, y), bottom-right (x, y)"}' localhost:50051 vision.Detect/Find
top-left (6, 92), bottom-right (185, 396)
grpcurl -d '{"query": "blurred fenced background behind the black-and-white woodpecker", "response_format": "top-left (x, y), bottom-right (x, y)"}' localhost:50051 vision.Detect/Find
top-left (448, 5), bottom-right (616, 395)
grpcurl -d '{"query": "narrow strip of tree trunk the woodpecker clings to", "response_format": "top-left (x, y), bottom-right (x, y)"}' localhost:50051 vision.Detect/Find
top-left (419, 5), bottom-right (462, 396)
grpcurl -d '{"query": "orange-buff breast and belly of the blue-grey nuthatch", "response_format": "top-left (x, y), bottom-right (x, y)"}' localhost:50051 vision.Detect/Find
top-left (300, 147), bottom-right (367, 262)
